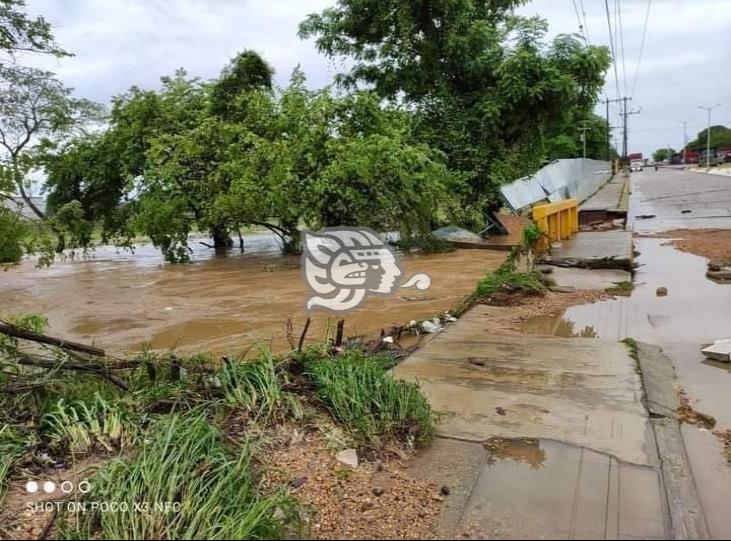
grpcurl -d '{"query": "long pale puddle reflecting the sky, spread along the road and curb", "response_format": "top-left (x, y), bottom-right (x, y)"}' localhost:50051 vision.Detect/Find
top-left (524, 238), bottom-right (731, 537)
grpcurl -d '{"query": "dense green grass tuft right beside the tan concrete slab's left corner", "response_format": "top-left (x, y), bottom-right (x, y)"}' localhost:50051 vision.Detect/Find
top-left (306, 350), bottom-right (434, 446)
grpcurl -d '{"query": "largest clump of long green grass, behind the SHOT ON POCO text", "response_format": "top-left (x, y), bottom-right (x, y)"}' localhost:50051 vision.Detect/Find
top-left (61, 414), bottom-right (294, 539)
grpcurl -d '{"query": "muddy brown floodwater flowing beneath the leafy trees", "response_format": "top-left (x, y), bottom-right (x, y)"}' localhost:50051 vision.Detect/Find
top-left (0, 234), bottom-right (505, 353)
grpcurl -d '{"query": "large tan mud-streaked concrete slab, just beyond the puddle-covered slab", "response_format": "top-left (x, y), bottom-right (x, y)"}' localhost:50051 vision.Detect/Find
top-left (395, 306), bottom-right (650, 465)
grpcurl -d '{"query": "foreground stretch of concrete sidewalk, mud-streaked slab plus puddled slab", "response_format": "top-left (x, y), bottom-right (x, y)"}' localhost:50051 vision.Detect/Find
top-left (396, 305), bottom-right (705, 539)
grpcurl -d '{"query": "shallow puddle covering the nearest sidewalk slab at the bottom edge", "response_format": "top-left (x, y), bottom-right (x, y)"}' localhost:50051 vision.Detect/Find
top-left (460, 438), bottom-right (668, 539)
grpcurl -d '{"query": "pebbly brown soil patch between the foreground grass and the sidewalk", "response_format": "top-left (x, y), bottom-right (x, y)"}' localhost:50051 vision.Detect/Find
top-left (264, 433), bottom-right (446, 539)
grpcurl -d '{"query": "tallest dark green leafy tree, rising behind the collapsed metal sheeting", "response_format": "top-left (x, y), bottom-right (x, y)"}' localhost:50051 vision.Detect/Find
top-left (300, 0), bottom-right (610, 221)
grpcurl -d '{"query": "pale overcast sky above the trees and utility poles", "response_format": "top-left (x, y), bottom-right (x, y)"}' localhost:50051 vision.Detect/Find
top-left (20, 0), bottom-right (731, 155)
